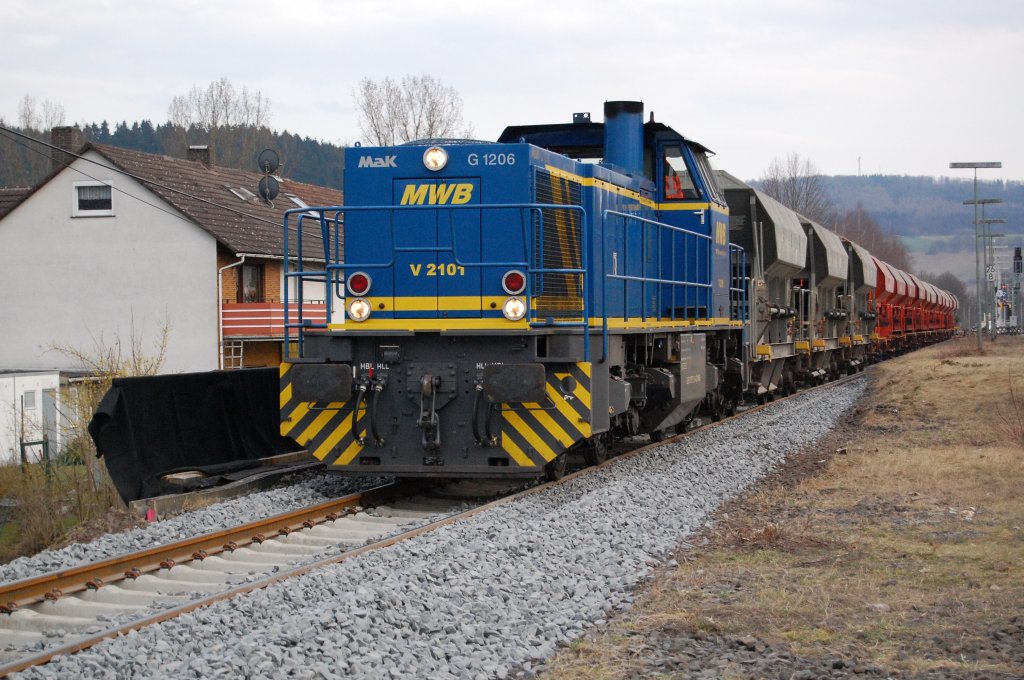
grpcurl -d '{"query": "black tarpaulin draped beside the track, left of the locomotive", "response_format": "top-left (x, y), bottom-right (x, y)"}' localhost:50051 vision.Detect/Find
top-left (89, 369), bottom-right (299, 503)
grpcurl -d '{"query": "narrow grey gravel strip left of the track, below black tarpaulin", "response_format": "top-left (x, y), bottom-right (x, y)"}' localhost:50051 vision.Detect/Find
top-left (0, 471), bottom-right (383, 583)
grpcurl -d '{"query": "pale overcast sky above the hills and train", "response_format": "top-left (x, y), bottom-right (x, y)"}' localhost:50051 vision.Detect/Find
top-left (0, 0), bottom-right (1024, 180)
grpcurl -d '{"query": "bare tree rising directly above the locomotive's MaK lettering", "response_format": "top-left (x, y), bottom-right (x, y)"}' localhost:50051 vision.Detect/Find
top-left (352, 74), bottom-right (473, 146)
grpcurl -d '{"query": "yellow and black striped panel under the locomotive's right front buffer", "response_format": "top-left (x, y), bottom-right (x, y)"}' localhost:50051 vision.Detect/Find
top-left (501, 363), bottom-right (591, 467)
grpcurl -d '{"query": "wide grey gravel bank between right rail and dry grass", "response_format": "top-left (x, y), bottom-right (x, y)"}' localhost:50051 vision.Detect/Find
top-left (18, 379), bottom-right (866, 679)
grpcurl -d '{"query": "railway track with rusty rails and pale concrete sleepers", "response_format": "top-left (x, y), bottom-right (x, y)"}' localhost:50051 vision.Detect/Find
top-left (0, 376), bottom-right (857, 676)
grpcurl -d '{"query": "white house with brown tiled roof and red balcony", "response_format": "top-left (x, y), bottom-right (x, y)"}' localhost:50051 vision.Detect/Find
top-left (0, 128), bottom-right (342, 372)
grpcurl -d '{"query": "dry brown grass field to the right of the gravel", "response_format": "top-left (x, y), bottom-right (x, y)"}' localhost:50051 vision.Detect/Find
top-left (550, 338), bottom-right (1024, 678)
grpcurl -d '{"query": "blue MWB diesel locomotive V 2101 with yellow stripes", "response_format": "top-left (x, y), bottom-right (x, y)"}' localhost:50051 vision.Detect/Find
top-left (281, 101), bottom-right (748, 478)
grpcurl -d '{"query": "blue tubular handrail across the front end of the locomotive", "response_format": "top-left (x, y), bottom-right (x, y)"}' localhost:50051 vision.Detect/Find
top-left (284, 203), bottom-right (591, 360)
